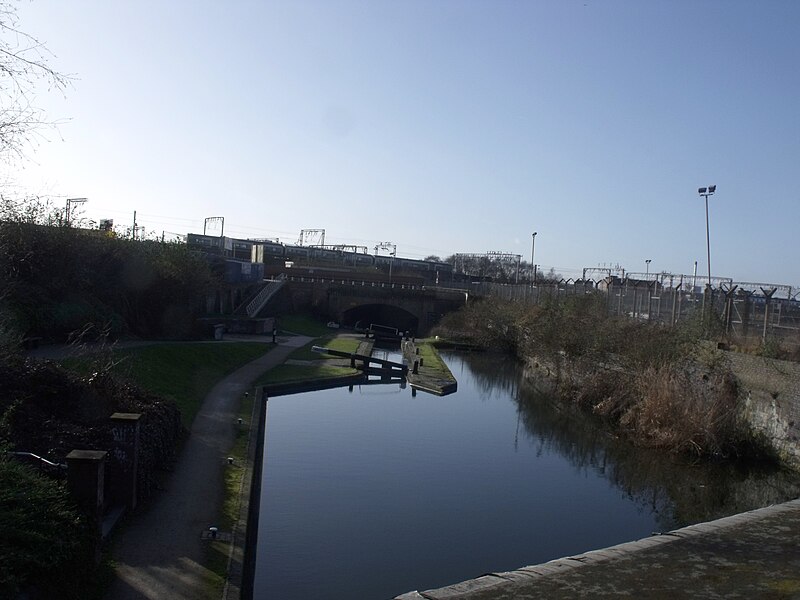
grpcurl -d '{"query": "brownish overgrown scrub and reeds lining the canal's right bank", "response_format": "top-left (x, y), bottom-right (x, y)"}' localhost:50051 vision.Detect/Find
top-left (434, 294), bottom-right (763, 456)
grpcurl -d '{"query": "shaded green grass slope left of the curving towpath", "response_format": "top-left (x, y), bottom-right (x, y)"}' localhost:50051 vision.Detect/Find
top-left (64, 342), bottom-right (272, 427)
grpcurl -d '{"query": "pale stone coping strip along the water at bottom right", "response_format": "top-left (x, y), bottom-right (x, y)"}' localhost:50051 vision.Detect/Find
top-left (393, 498), bottom-right (800, 600)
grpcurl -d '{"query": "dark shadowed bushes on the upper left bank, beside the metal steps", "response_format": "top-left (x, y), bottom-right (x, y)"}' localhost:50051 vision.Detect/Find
top-left (0, 220), bottom-right (217, 340)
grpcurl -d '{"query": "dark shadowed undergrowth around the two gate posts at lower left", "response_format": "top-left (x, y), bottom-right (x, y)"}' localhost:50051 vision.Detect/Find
top-left (0, 345), bottom-right (181, 598)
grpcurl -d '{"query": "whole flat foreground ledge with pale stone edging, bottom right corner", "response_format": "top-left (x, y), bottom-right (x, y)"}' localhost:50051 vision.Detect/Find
top-left (395, 499), bottom-right (800, 600)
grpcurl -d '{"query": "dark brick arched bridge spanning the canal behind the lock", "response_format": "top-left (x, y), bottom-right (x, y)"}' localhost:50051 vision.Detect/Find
top-left (284, 276), bottom-right (467, 335)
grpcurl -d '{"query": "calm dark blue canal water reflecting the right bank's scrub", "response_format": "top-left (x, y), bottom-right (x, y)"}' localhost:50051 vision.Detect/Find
top-left (254, 354), bottom-right (800, 600)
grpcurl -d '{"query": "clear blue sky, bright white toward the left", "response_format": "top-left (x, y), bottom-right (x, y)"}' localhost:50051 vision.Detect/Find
top-left (6, 0), bottom-right (800, 285)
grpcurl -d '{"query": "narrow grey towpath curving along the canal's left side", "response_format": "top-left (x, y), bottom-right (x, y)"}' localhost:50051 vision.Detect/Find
top-left (97, 335), bottom-right (313, 600)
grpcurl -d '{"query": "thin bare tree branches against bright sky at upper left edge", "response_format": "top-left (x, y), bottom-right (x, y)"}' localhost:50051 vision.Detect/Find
top-left (0, 0), bottom-right (72, 160)
